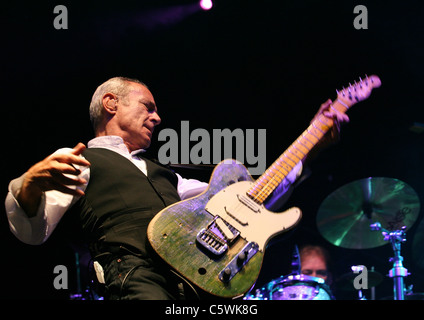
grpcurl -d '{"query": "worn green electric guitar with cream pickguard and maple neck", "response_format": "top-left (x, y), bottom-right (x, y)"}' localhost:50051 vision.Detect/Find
top-left (147, 76), bottom-right (381, 298)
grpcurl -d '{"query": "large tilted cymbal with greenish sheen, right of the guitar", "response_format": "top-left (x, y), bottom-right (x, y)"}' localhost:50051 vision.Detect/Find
top-left (316, 177), bottom-right (420, 249)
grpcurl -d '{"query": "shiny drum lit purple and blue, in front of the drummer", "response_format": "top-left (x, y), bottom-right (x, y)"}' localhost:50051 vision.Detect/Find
top-left (244, 274), bottom-right (333, 300)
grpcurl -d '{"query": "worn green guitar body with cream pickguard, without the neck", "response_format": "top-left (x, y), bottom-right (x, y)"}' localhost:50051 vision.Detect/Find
top-left (147, 160), bottom-right (301, 298)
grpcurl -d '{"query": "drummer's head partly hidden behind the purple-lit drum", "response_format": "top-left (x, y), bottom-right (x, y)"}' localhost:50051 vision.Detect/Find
top-left (299, 245), bottom-right (331, 285)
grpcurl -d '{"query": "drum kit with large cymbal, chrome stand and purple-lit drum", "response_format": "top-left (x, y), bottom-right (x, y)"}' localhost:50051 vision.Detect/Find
top-left (243, 177), bottom-right (424, 300)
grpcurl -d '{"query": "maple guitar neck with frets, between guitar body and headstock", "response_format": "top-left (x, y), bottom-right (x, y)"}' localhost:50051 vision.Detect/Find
top-left (247, 99), bottom-right (350, 204)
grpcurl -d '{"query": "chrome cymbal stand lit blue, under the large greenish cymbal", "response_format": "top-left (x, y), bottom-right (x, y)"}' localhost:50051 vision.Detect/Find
top-left (370, 222), bottom-right (410, 300)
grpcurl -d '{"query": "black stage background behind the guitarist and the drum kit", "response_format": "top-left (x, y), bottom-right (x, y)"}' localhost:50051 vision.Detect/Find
top-left (0, 0), bottom-right (424, 299)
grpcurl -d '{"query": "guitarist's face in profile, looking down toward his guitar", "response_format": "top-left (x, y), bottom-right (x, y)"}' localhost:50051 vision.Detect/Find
top-left (115, 82), bottom-right (161, 151)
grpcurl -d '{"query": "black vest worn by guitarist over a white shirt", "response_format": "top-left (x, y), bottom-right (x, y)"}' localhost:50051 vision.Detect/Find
top-left (67, 148), bottom-right (180, 257)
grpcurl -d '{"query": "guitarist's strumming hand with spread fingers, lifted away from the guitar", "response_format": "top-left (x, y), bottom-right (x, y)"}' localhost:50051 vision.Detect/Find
top-left (17, 143), bottom-right (90, 217)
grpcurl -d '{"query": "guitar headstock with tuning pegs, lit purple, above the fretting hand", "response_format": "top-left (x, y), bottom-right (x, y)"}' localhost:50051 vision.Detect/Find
top-left (336, 75), bottom-right (381, 107)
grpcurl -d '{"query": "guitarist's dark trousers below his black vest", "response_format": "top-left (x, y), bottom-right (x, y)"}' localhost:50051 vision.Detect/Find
top-left (102, 254), bottom-right (184, 300)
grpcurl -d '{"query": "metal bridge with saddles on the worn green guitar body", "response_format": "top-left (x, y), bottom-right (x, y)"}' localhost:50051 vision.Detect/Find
top-left (196, 217), bottom-right (240, 256)
